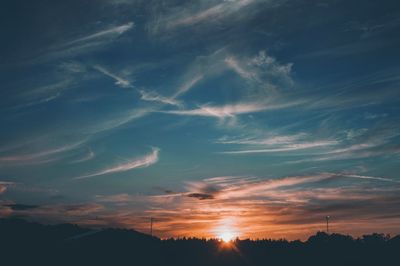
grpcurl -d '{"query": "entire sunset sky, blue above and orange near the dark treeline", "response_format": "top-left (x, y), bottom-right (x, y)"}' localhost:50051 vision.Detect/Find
top-left (0, 0), bottom-right (400, 239)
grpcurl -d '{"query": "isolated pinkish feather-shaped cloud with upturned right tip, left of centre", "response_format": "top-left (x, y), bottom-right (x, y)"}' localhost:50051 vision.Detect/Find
top-left (74, 148), bottom-right (160, 179)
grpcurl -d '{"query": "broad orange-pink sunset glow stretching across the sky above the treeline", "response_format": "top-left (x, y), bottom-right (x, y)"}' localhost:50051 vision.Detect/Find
top-left (6, 173), bottom-right (400, 243)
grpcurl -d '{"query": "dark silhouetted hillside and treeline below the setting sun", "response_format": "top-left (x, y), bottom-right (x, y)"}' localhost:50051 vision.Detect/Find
top-left (0, 219), bottom-right (400, 266)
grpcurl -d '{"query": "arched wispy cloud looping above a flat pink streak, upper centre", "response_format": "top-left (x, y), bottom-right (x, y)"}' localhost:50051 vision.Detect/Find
top-left (154, 48), bottom-right (305, 129)
